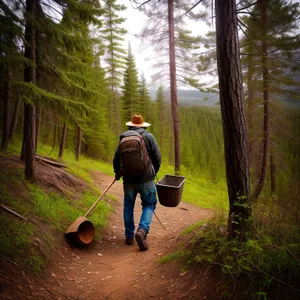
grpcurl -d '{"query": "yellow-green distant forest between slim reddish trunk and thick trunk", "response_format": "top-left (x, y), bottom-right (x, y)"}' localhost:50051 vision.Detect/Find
top-left (180, 107), bottom-right (225, 183)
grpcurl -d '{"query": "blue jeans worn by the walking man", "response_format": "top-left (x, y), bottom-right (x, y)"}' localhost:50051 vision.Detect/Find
top-left (123, 180), bottom-right (157, 238)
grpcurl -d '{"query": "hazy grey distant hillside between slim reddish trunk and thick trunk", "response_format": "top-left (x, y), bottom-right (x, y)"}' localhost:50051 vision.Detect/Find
top-left (149, 88), bottom-right (219, 106)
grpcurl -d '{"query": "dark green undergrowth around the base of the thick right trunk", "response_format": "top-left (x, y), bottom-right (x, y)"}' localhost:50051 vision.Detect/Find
top-left (160, 207), bottom-right (300, 300)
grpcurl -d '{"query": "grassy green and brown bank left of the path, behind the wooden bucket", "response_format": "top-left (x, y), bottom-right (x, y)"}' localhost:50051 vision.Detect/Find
top-left (0, 154), bottom-right (114, 272)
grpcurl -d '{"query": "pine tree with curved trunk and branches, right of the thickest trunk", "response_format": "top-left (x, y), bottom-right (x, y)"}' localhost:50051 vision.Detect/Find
top-left (240, 0), bottom-right (300, 201)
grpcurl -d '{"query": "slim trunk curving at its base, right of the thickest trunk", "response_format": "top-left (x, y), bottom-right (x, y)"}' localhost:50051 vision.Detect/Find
top-left (251, 0), bottom-right (270, 201)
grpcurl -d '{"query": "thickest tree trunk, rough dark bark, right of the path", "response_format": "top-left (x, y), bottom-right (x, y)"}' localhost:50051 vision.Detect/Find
top-left (216, 0), bottom-right (251, 240)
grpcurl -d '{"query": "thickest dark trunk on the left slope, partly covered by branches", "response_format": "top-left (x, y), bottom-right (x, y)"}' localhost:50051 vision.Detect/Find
top-left (24, 0), bottom-right (36, 180)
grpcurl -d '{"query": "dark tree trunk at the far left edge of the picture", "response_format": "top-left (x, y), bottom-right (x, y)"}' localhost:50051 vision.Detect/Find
top-left (1, 66), bottom-right (10, 150)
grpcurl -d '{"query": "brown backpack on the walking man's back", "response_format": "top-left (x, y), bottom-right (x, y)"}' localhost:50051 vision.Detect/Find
top-left (119, 130), bottom-right (151, 177)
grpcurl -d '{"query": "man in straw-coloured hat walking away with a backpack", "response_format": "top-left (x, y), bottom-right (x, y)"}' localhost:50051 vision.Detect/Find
top-left (113, 115), bottom-right (161, 251)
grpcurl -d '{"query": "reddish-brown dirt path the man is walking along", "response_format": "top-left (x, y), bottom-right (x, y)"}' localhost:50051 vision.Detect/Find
top-left (2, 172), bottom-right (212, 300)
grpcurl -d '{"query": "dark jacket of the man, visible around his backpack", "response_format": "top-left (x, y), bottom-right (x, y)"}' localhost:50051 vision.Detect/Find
top-left (113, 127), bottom-right (161, 183)
